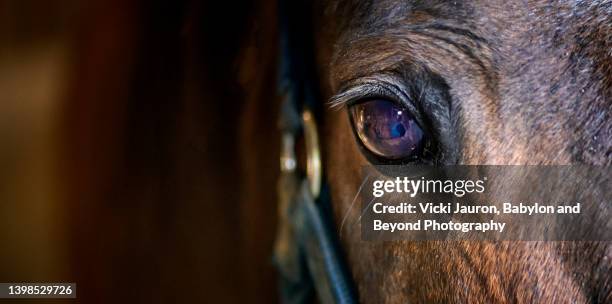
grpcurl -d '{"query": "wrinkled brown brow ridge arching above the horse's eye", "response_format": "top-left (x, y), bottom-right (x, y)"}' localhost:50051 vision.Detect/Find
top-left (330, 20), bottom-right (495, 84)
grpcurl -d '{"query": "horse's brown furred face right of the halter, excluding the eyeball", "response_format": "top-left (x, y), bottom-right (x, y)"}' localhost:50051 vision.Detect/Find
top-left (316, 1), bottom-right (612, 303)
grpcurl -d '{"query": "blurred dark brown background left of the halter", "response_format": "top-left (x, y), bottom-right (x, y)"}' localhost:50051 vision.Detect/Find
top-left (0, 0), bottom-right (278, 303)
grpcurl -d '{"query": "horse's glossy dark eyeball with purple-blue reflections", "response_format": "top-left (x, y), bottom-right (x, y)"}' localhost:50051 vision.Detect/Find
top-left (349, 99), bottom-right (425, 160)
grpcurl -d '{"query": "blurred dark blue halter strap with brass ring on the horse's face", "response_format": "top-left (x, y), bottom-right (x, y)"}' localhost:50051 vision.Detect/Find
top-left (274, 0), bottom-right (357, 304)
